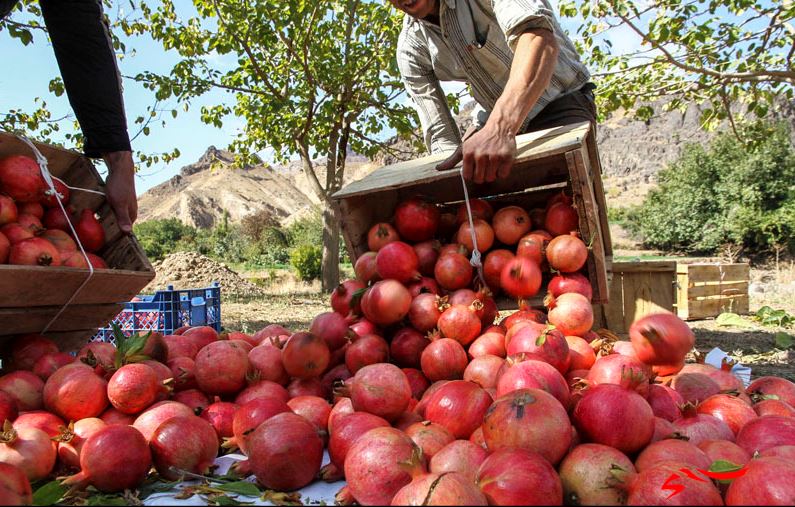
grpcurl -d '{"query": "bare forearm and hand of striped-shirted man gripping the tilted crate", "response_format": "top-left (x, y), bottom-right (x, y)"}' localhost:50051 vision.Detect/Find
top-left (463, 28), bottom-right (559, 183)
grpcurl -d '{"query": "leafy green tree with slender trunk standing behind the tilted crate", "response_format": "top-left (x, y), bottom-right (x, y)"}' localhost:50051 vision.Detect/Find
top-left (124, 0), bottom-right (419, 291)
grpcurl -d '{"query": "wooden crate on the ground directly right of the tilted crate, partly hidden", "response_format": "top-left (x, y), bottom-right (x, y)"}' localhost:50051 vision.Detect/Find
top-left (594, 261), bottom-right (676, 335)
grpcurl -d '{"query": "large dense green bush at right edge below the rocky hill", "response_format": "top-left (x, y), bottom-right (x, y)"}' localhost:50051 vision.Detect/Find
top-left (627, 122), bottom-right (795, 254)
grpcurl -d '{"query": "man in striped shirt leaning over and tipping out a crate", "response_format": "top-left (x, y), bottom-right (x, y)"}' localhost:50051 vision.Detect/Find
top-left (389, 0), bottom-right (596, 183)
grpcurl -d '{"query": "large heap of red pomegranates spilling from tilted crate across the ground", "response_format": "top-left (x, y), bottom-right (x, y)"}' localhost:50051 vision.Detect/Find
top-left (0, 195), bottom-right (795, 505)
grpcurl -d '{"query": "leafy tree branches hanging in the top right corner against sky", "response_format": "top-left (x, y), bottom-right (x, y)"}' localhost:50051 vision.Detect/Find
top-left (559, 0), bottom-right (795, 131)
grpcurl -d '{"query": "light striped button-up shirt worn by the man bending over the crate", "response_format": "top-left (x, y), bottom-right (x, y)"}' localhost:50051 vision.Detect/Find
top-left (397, 0), bottom-right (590, 153)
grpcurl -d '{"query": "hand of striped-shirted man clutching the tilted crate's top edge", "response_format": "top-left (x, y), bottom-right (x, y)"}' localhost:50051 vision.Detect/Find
top-left (463, 123), bottom-right (516, 183)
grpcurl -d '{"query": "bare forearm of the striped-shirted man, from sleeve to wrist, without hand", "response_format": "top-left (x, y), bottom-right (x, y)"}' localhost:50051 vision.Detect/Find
top-left (488, 28), bottom-right (558, 136)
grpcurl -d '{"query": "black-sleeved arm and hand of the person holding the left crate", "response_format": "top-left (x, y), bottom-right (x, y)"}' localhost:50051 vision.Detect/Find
top-left (0, 0), bottom-right (138, 233)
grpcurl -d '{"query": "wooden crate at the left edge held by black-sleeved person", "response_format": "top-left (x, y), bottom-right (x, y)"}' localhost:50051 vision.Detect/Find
top-left (0, 132), bottom-right (155, 351)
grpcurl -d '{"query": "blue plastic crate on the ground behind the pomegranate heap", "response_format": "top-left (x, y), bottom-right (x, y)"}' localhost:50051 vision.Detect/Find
top-left (91, 282), bottom-right (221, 342)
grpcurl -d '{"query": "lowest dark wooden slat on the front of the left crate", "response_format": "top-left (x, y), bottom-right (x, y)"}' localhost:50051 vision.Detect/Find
top-left (0, 304), bottom-right (124, 334)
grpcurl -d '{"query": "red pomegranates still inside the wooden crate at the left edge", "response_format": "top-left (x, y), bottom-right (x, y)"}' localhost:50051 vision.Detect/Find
top-left (0, 155), bottom-right (108, 269)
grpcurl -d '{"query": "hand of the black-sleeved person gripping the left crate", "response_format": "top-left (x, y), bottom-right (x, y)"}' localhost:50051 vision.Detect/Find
top-left (102, 151), bottom-right (138, 234)
